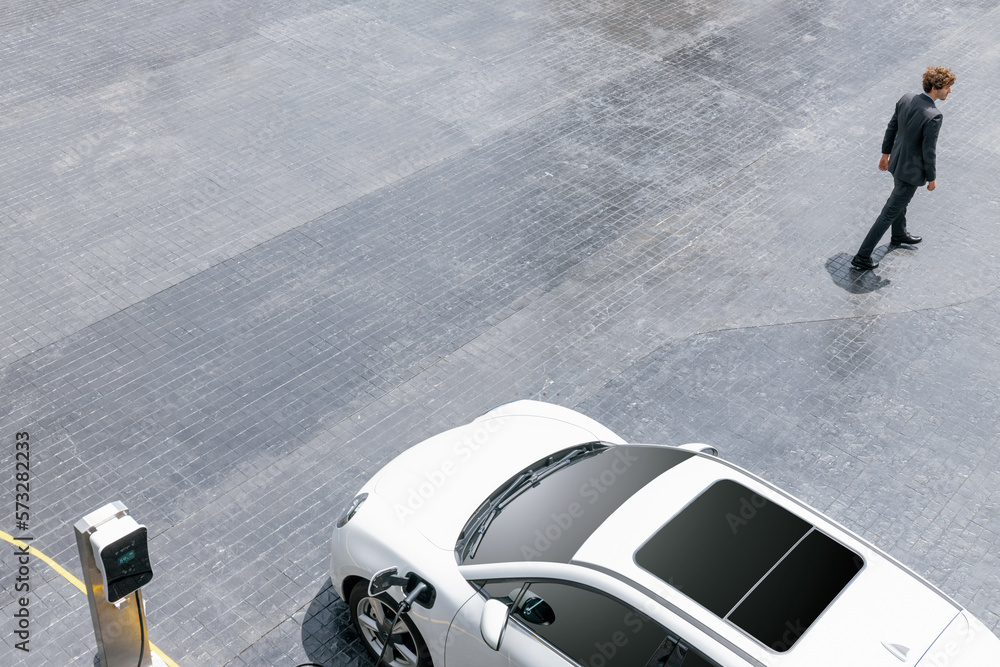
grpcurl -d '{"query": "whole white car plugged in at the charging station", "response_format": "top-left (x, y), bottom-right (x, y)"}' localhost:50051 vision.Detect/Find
top-left (332, 401), bottom-right (1000, 667)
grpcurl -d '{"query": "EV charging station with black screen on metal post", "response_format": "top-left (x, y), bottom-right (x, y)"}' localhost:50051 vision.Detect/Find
top-left (73, 501), bottom-right (165, 667)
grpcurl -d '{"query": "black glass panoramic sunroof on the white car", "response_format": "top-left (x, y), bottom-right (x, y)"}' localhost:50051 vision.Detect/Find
top-left (635, 480), bottom-right (864, 651)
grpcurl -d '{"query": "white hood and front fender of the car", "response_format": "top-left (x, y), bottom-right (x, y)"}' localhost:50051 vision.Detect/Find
top-left (331, 401), bottom-right (624, 665)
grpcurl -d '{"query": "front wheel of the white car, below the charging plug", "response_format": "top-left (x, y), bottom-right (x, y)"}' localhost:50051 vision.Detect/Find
top-left (349, 581), bottom-right (432, 667)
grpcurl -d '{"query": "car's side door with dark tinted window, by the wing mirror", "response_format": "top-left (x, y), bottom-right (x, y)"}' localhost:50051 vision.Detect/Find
top-left (451, 580), bottom-right (717, 667)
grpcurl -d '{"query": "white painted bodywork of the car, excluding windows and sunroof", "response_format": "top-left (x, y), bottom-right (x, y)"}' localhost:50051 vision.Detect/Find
top-left (332, 401), bottom-right (1000, 667)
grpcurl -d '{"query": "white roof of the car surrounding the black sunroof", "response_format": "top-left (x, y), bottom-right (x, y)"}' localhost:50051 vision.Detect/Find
top-left (572, 455), bottom-right (961, 665)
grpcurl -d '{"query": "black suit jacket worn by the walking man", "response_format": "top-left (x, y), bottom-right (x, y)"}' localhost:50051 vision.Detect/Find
top-left (882, 93), bottom-right (944, 186)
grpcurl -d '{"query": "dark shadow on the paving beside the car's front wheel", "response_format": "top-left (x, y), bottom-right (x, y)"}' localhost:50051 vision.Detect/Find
top-left (302, 578), bottom-right (372, 667)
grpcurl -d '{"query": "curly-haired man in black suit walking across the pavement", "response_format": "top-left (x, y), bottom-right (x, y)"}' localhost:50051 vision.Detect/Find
top-left (851, 67), bottom-right (955, 271)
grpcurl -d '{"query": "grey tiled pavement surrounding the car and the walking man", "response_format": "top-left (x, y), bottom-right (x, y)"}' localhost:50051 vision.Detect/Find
top-left (0, 0), bottom-right (1000, 667)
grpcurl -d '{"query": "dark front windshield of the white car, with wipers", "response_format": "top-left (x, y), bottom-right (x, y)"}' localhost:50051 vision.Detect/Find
top-left (455, 443), bottom-right (694, 564)
